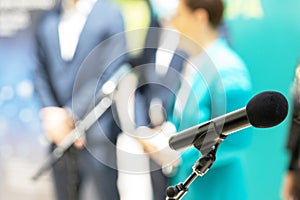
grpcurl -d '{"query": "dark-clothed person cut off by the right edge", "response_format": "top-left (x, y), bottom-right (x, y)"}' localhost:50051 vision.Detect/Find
top-left (281, 63), bottom-right (300, 200)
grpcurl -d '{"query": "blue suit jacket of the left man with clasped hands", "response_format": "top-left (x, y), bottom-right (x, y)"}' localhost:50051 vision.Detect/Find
top-left (35, 0), bottom-right (125, 170)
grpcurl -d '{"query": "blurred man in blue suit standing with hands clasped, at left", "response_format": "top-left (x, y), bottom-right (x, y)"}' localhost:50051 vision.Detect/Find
top-left (35, 0), bottom-right (125, 200)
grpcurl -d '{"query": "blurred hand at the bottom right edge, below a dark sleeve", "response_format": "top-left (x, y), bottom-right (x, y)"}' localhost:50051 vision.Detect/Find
top-left (281, 171), bottom-right (298, 200)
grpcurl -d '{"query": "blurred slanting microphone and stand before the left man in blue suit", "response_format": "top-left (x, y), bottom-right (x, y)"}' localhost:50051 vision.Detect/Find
top-left (32, 64), bottom-right (131, 180)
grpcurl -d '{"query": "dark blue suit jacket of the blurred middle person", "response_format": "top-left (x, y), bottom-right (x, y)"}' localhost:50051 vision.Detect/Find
top-left (135, 28), bottom-right (187, 127)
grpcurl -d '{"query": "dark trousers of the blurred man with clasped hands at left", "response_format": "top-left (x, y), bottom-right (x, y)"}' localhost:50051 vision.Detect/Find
top-left (53, 147), bottom-right (119, 200)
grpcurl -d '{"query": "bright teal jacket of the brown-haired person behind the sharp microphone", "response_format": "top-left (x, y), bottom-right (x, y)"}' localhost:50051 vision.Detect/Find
top-left (170, 39), bottom-right (251, 200)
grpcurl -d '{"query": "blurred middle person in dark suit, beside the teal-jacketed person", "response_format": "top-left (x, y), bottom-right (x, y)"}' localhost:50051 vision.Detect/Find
top-left (135, 27), bottom-right (186, 199)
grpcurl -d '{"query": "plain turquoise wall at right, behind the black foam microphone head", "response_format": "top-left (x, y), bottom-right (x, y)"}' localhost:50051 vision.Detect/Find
top-left (226, 0), bottom-right (300, 200)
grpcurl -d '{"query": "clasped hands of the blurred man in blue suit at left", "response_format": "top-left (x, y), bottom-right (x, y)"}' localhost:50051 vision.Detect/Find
top-left (40, 107), bottom-right (84, 148)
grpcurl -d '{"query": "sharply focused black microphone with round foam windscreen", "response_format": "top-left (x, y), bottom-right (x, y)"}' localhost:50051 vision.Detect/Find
top-left (169, 91), bottom-right (288, 150)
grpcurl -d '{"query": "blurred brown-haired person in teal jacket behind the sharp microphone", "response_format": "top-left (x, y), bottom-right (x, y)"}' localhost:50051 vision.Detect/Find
top-left (169, 0), bottom-right (251, 200)
